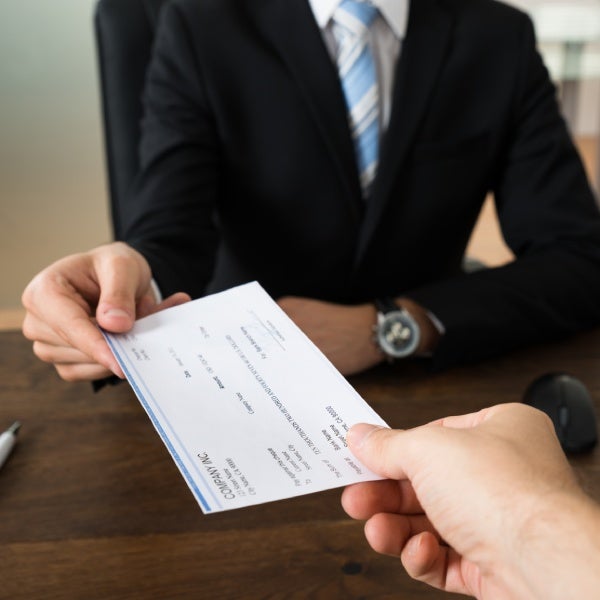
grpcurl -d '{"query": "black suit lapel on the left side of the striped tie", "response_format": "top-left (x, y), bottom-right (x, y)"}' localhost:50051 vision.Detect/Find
top-left (248, 0), bottom-right (362, 223)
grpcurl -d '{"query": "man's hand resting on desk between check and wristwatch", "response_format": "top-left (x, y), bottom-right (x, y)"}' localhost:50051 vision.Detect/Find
top-left (278, 296), bottom-right (383, 375)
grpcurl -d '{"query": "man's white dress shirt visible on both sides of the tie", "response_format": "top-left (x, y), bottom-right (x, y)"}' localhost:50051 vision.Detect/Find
top-left (308, 0), bottom-right (409, 132)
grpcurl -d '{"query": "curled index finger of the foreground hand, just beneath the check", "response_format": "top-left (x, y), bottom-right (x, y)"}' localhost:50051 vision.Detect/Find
top-left (342, 479), bottom-right (423, 520)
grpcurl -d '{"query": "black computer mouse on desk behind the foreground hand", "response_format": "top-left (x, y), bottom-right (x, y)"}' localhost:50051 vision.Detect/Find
top-left (523, 373), bottom-right (598, 452)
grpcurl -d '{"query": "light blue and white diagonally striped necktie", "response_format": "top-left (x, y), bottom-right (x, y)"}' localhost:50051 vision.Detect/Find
top-left (333, 0), bottom-right (379, 197)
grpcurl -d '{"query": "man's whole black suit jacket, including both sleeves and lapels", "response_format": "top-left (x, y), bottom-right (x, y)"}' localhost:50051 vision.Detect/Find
top-left (125, 0), bottom-right (600, 367)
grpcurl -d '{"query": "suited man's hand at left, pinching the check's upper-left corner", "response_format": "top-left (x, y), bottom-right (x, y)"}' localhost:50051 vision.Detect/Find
top-left (22, 242), bottom-right (190, 381)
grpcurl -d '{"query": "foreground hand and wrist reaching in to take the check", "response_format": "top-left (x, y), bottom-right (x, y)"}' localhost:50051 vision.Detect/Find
top-left (342, 404), bottom-right (600, 599)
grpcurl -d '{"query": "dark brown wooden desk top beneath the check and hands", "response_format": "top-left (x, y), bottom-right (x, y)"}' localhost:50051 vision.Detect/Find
top-left (0, 331), bottom-right (600, 600)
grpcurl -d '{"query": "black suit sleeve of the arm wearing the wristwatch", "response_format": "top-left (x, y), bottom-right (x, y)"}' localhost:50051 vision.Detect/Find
top-left (406, 14), bottom-right (600, 368)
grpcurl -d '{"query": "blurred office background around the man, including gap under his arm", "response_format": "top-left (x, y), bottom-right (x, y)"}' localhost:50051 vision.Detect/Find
top-left (0, 0), bottom-right (600, 327)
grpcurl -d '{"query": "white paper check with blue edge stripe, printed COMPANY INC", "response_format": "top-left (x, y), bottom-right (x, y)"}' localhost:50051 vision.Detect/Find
top-left (105, 282), bottom-right (385, 513)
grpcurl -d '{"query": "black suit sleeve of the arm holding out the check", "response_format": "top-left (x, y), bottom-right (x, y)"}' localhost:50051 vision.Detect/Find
top-left (124, 0), bottom-right (219, 296)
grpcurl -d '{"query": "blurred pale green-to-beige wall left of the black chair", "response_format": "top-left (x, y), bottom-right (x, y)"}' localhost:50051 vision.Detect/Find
top-left (0, 0), bottom-right (110, 308)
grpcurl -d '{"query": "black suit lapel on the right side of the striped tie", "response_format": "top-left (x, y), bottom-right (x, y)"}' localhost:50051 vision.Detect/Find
top-left (355, 0), bottom-right (453, 264)
